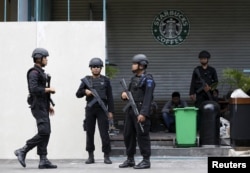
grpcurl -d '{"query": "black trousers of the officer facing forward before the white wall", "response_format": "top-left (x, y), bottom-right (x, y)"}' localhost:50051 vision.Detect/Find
top-left (84, 104), bottom-right (111, 154)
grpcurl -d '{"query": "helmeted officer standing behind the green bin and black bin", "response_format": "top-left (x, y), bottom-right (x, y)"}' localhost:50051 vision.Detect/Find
top-left (189, 50), bottom-right (218, 128)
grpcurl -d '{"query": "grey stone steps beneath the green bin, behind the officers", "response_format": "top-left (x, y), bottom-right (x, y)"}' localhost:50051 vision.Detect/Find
top-left (111, 132), bottom-right (232, 157)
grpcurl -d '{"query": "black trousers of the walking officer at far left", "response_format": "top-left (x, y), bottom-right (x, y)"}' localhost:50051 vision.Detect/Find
top-left (26, 107), bottom-right (51, 155)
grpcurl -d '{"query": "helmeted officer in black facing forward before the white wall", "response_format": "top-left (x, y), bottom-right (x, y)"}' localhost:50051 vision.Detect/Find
top-left (76, 58), bottom-right (114, 164)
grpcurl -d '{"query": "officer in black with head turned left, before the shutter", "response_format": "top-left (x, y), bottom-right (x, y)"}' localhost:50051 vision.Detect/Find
top-left (119, 54), bottom-right (155, 169)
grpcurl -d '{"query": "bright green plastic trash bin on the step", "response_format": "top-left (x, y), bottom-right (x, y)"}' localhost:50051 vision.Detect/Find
top-left (174, 107), bottom-right (199, 147)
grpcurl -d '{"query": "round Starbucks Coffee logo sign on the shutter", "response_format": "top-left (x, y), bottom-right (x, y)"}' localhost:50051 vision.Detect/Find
top-left (152, 10), bottom-right (189, 46)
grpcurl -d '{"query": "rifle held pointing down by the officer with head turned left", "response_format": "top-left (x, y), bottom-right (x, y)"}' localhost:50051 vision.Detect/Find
top-left (120, 78), bottom-right (144, 132)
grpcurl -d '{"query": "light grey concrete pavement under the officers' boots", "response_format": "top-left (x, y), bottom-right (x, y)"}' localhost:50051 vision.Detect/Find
top-left (0, 156), bottom-right (207, 173)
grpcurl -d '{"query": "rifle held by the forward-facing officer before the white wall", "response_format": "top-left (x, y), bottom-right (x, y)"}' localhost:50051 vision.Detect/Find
top-left (83, 77), bottom-right (109, 116)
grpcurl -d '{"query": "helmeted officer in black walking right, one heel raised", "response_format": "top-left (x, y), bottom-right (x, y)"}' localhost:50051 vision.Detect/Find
top-left (14, 48), bottom-right (57, 169)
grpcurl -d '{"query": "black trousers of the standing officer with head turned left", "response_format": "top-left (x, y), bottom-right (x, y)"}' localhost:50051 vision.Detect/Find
top-left (123, 108), bottom-right (151, 158)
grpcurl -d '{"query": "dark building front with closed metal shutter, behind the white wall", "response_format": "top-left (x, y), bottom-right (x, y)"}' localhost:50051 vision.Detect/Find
top-left (0, 0), bottom-right (250, 127)
